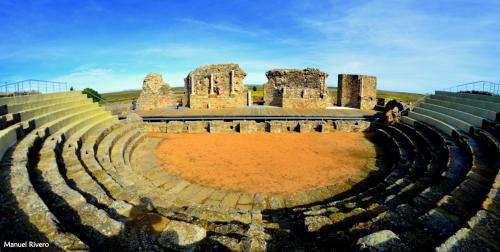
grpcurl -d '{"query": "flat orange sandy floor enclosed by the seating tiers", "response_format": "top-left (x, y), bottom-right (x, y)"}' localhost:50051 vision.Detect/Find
top-left (149, 132), bottom-right (376, 194)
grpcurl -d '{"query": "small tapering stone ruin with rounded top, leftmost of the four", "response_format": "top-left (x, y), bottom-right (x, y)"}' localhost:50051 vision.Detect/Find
top-left (137, 73), bottom-right (177, 110)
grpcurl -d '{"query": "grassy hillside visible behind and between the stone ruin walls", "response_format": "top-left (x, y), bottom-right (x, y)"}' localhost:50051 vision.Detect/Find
top-left (102, 85), bottom-right (424, 103)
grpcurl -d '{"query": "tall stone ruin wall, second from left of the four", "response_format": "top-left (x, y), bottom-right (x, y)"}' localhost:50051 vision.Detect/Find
top-left (184, 64), bottom-right (248, 109)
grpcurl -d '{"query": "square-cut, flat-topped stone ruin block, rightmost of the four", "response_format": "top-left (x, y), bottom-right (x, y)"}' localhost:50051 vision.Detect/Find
top-left (337, 74), bottom-right (377, 110)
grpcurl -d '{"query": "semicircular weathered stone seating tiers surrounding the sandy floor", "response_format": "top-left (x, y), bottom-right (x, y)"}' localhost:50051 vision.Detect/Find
top-left (0, 92), bottom-right (500, 251)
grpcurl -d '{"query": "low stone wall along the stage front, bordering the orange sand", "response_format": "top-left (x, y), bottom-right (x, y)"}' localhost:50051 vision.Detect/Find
top-left (142, 120), bottom-right (376, 133)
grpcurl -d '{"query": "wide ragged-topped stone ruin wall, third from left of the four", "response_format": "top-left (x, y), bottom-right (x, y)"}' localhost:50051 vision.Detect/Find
top-left (264, 68), bottom-right (332, 108)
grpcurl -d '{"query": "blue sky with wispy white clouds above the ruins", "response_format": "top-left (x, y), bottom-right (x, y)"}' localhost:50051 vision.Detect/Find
top-left (0, 0), bottom-right (500, 93)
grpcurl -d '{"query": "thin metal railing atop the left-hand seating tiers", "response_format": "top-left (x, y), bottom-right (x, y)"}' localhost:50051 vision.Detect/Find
top-left (0, 79), bottom-right (68, 95)
